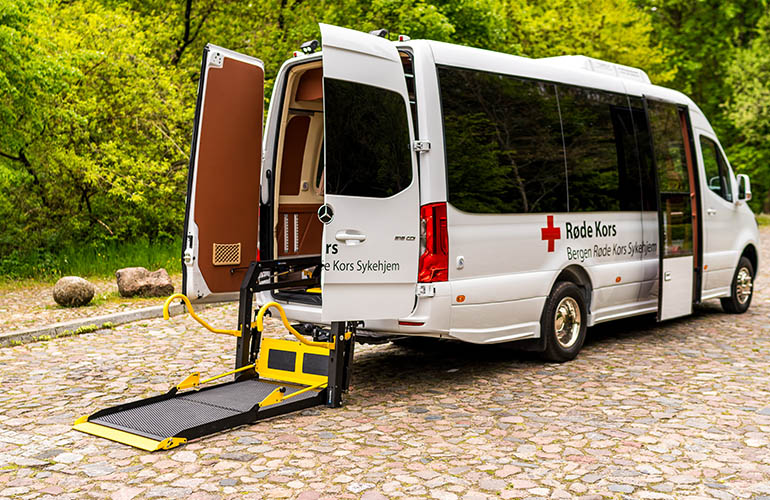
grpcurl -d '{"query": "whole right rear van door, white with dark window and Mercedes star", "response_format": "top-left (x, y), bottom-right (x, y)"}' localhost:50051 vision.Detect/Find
top-left (318, 24), bottom-right (420, 321)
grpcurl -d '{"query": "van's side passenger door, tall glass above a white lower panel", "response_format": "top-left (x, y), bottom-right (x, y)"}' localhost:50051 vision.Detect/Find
top-left (645, 99), bottom-right (698, 321)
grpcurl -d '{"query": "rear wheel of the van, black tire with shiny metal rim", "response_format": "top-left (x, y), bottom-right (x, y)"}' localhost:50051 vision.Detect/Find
top-left (540, 281), bottom-right (588, 363)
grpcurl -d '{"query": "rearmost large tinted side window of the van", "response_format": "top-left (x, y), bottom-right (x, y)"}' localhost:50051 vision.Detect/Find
top-left (438, 67), bottom-right (567, 213)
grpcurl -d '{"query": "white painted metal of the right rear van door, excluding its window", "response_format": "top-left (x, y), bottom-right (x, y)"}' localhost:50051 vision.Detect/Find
top-left (321, 24), bottom-right (420, 322)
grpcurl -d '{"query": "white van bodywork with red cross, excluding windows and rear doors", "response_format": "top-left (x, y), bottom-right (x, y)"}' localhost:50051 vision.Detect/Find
top-left (260, 30), bottom-right (759, 343)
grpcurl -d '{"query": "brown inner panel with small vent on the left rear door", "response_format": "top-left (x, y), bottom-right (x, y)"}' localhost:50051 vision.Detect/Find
top-left (194, 57), bottom-right (264, 293)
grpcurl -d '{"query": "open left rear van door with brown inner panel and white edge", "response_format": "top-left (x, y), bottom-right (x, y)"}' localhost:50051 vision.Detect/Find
top-left (182, 45), bottom-right (265, 301)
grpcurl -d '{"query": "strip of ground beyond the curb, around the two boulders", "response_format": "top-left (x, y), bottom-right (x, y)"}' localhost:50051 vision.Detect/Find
top-left (0, 274), bottom-right (182, 333)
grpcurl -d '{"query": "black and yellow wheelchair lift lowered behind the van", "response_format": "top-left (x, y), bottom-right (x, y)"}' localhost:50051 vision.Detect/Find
top-left (74, 261), bottom-right (355, 451)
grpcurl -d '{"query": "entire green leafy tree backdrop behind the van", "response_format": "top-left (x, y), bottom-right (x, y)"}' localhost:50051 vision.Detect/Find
top-left (0, 0), bottom-right (770, 274)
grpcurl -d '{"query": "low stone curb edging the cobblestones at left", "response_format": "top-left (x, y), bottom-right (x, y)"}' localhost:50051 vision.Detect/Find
top-left (0, 302), bottom-right (227, 347)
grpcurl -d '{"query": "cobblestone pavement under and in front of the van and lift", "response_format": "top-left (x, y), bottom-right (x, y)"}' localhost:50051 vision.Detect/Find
top-left (0, 237), bottom-right (770, 500)
